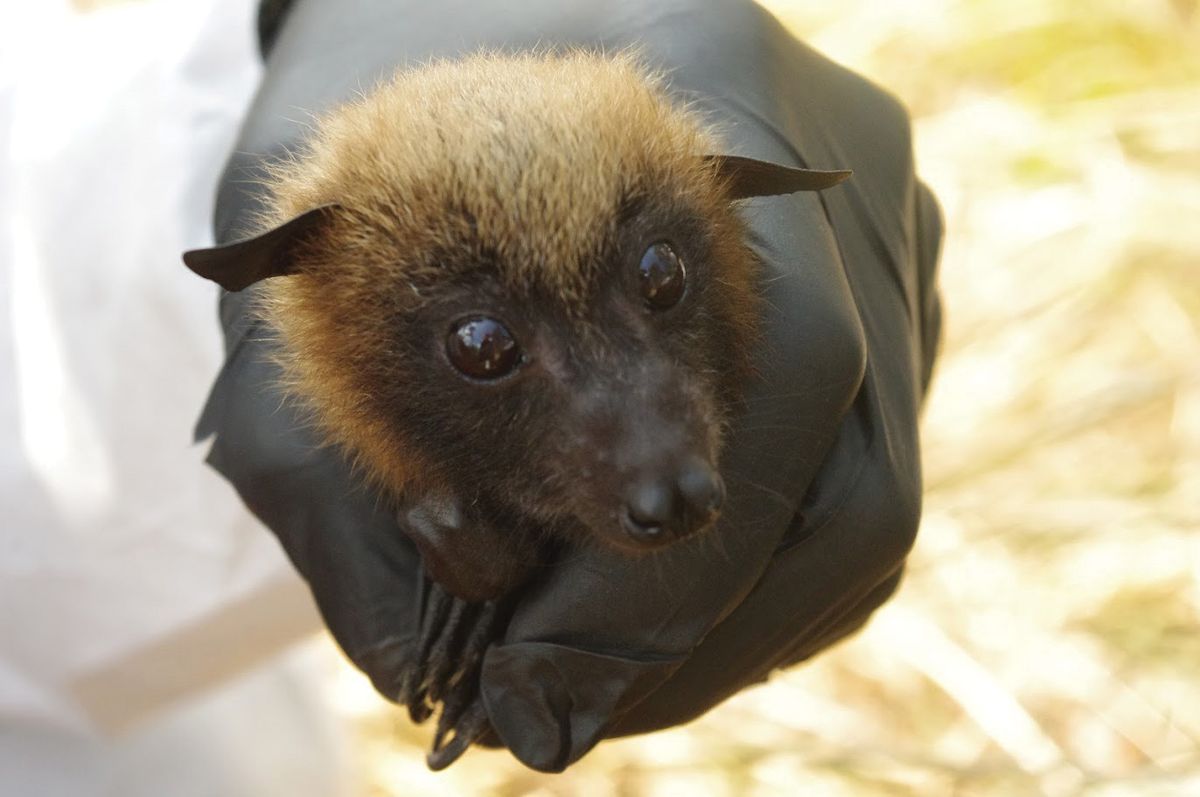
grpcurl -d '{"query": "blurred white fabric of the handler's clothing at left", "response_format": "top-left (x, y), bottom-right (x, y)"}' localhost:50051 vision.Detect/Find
top-left (0, 0), bottom-right (348, 796)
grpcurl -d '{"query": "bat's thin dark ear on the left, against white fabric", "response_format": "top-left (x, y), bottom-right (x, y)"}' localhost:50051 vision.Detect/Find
top-left (184, 205), bottom-right (341, 292)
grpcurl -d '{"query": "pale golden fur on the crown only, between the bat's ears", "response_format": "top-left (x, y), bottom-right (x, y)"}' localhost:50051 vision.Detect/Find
top-left (260, 53), bottom-right (712, 301)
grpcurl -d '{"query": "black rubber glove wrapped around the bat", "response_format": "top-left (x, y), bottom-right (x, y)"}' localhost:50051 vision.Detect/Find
top-left (198, 0), bottom-right (941, 771)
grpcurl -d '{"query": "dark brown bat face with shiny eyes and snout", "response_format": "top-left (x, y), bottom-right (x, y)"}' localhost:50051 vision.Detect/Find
top-left (378, 189), bottom-right (752, 549)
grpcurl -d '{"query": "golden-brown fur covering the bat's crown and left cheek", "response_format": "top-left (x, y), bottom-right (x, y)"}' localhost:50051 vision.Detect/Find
top-left (264, 53), bottom-right (749, 499)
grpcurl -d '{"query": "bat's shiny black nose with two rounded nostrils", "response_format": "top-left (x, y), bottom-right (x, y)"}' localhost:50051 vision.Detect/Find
top-left (622, 457), bottom-right (725, 546)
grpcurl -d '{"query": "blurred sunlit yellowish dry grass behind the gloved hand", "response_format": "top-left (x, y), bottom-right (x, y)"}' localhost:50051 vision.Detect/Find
top-left (9, 0), bottom-right (1200, 797)
